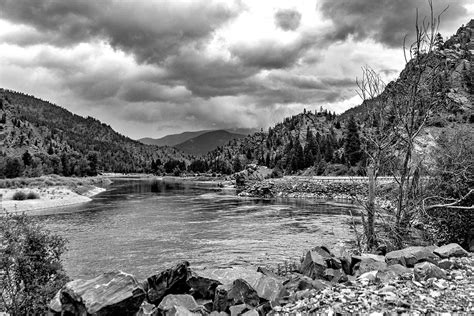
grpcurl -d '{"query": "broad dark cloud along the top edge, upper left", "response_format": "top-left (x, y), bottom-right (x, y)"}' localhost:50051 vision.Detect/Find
top-left (0, 0), bottom-right (239, 62)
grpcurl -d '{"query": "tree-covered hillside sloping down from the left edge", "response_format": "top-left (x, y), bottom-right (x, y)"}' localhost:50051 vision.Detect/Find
top-left (0, 89), bottom-right (186, 178)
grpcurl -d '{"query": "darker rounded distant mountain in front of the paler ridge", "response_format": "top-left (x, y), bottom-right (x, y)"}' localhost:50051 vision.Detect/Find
top-left (175, 130), bottom-right (245, 156)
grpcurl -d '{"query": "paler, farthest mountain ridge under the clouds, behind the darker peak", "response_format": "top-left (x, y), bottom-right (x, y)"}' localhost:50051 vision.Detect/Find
top-left (138, 128), bottom-right (258, 146)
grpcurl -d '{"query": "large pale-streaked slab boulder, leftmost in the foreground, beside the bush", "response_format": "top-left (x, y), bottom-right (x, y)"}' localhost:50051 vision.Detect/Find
top-left (50, 271), bottom-right (145, 315)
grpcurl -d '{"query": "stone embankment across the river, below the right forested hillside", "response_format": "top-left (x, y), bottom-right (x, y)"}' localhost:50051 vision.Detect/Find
top-left (239, 177), bottom-right (367, 200)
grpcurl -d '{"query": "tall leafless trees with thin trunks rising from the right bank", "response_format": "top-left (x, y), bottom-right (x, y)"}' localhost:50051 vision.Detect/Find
top-left (357, 1), bottom-right (447, 248)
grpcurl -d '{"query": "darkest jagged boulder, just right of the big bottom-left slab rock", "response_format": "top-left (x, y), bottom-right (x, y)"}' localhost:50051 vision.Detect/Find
top-left (144, 261), bottom-right (190, 306)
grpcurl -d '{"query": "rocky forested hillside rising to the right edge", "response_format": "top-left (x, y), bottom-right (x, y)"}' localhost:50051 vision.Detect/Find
top-left (188, 20), bottom-right (474, 175)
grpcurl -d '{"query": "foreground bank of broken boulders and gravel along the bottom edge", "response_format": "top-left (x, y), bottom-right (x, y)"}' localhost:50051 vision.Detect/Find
top-left (50, 244), bottom-right (474, 315)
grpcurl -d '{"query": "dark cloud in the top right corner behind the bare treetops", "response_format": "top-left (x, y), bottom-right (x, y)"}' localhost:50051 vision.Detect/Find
top-left (320, 0), bottom-right (468, 47)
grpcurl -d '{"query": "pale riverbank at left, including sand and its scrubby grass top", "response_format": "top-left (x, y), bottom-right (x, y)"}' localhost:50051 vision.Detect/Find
top-left (0, 176), bottom-right (111, 213)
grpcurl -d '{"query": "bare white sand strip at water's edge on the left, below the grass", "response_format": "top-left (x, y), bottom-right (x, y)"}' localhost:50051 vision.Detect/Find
top-left (0, 185), bottom-right (105, 213)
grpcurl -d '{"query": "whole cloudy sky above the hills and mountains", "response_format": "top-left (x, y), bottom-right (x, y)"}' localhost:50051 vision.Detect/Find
top-left (0, 0), bottom-right (474, 138)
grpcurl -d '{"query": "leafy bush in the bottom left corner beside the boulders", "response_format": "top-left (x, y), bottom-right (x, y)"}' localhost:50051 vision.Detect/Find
top-left (0, 214), bottom-right (69, 315)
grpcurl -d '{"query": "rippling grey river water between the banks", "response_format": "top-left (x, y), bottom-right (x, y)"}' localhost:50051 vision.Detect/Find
top-left (39, 180), bottom-right (352, 279)
